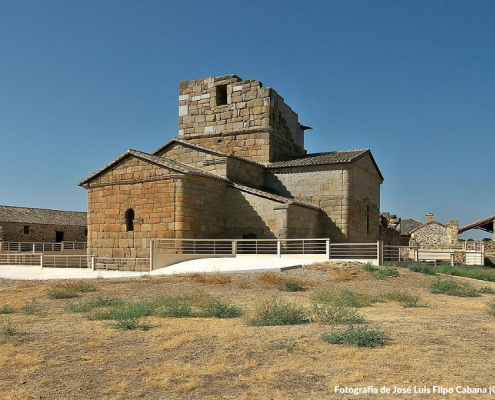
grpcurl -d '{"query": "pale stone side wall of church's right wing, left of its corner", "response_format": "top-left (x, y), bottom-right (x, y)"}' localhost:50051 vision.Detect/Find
top-left (265, 165), bottom-right (349, 242)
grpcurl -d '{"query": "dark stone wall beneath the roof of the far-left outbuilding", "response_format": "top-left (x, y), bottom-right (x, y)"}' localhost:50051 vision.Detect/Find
top-left (0, 222), bottom-right (87, 243)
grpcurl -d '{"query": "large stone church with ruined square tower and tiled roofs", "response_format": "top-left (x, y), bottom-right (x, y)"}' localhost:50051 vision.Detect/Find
top-left (79, 75), bottom-right (383, 257)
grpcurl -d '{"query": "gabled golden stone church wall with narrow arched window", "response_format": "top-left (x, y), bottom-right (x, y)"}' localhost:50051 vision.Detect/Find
top-left (88, 158), bottom-right (182, 257)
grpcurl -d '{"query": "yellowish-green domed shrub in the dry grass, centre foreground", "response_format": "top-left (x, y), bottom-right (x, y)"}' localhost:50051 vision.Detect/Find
top-left (247, 297), bottom-right (309, 326)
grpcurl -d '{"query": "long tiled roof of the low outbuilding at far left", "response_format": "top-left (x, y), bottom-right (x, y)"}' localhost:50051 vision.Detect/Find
top-left (0, 206), bottom-right (86, 226)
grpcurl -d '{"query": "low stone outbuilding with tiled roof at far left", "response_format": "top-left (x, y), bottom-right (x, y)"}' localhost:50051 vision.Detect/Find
top-left (0, 205), bottom-right (87, 243)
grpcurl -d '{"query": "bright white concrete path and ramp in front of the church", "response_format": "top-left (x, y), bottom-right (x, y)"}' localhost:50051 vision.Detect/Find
top-left (0, 257), bottom-right (321, 280)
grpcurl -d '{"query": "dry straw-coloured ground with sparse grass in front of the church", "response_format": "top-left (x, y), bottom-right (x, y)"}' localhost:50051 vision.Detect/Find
top-left (0, 263), bottom-right (495, 399)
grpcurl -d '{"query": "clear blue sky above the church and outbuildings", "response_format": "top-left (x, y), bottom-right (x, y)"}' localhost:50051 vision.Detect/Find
top-left (0, 0), bottom-right (495, 237)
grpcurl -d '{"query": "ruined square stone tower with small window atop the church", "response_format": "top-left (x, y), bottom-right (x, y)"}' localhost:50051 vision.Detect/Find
top-left (179, 75), bottom-right (309, 164)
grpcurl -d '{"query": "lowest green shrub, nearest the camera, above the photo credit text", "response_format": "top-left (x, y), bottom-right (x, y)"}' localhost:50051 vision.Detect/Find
top-left (321, 324), bottom-right (388, 347)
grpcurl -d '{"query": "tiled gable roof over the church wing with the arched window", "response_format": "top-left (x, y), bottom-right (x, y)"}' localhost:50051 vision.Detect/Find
top-left (78, 149), bottom-right (231, 186)
